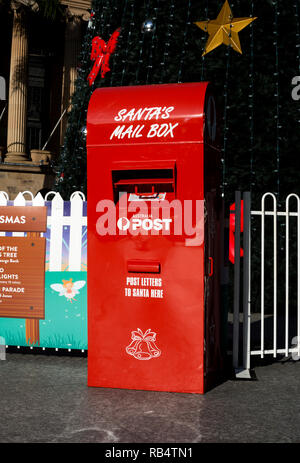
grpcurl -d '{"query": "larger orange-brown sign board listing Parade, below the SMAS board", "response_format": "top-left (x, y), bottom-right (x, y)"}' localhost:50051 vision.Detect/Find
top-left (0, 239), bottom-right (46, 319)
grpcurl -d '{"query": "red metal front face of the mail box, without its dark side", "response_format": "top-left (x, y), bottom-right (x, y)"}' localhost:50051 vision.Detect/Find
top-left (87, 83), bottom-right (220, 393)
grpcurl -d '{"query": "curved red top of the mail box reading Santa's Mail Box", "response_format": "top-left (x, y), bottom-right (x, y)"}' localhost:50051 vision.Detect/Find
top-left (87, 82), bottom-right (216, 148)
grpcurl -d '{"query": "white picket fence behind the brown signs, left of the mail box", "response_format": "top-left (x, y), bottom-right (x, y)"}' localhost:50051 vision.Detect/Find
top-left (0, 191), bottom-right (87, 272)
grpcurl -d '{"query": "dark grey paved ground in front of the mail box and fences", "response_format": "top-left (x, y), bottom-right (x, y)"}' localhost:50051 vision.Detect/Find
top-left (0, 354), bottom-right (300, 443)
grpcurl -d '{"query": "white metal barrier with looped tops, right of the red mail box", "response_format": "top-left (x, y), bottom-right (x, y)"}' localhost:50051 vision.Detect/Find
top-left (233, 192), bottom-right (300, 378)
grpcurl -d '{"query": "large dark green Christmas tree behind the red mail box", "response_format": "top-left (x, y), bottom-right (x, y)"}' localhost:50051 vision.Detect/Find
top-left (56, 0), bottom-right (300, 207)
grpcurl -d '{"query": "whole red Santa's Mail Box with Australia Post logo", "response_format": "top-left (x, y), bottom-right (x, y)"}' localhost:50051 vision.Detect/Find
top-left (87, 82), bottom-right (223, 393)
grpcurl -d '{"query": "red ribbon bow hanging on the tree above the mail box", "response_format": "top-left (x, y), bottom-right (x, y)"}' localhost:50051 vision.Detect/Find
top-left (87, 27), bottom-right (121, 85)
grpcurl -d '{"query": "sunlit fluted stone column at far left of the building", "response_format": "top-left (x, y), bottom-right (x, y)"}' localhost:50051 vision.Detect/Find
top-left (5, 4), bottom-right (28, 162)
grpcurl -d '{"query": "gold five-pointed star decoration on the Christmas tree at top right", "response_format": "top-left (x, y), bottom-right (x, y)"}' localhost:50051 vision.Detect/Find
top-left (195, 0), bottom-right (257, 56)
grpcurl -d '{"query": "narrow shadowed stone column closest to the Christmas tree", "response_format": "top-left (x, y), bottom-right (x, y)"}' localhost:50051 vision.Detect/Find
top-left (60, 13), bottom-right (82, 144)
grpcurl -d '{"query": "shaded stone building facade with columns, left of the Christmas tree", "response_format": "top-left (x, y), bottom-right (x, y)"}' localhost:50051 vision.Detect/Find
top-left (0, 0), bottom-right (91, 199)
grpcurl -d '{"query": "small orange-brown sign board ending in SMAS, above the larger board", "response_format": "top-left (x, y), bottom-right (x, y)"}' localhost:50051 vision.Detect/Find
top-left (0, 206), bottom-right (47, 232)
